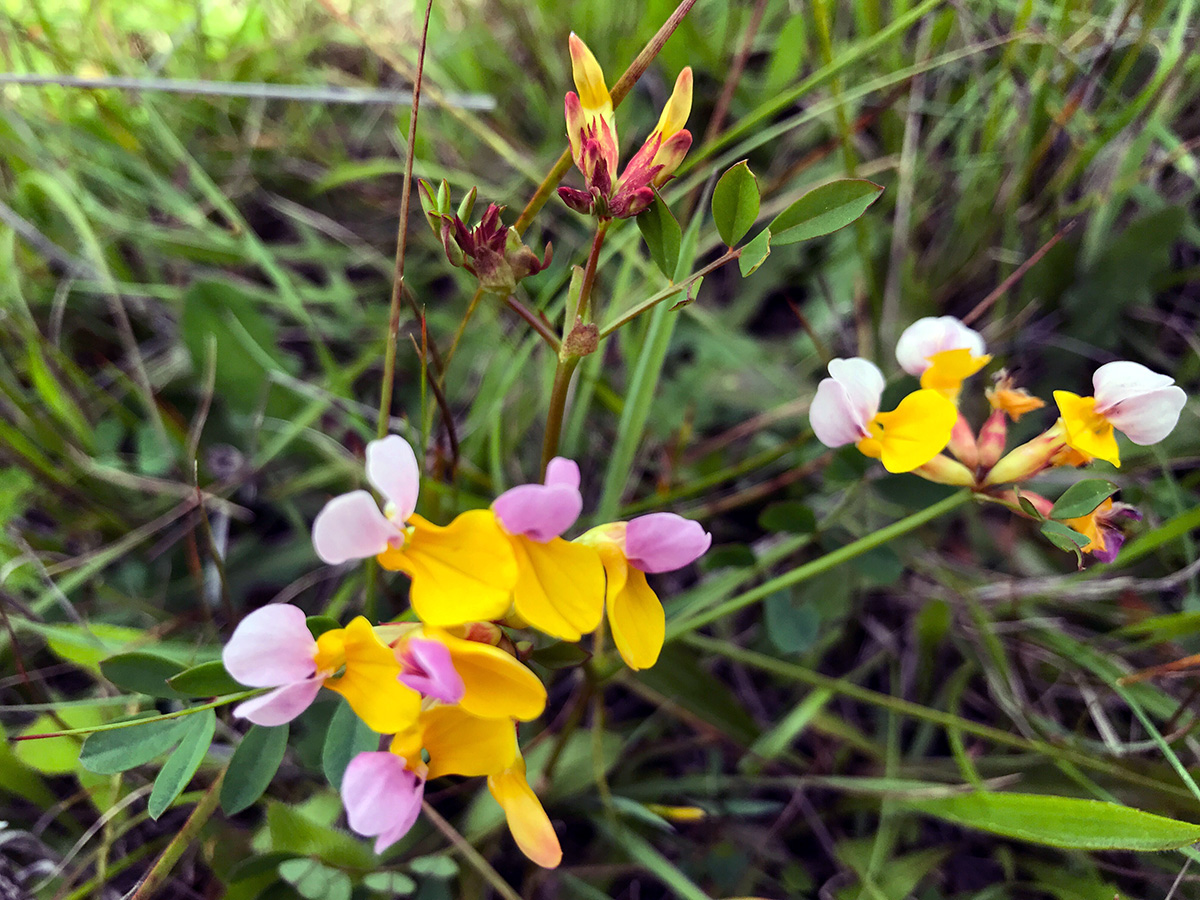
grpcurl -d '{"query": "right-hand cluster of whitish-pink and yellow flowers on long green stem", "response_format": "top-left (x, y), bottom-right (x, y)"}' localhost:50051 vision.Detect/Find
top-left (809, 316), bottom-right (1187, 562)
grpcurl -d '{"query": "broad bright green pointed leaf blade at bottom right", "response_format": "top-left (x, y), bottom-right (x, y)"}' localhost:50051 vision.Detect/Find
top-left (896, 792), bottom-right (1200, 851)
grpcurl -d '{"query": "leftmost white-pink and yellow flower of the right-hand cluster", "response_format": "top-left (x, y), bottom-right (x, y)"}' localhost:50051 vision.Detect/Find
top-left (809, 356), bottom-right (958, 472)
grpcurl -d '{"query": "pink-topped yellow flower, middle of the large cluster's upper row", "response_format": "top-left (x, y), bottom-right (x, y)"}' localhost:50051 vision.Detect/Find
top-left (492, 456), bottom-right (605, 641)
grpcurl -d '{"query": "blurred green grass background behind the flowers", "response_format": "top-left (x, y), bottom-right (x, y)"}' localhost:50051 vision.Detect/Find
top-left (0, 0), bottom-right (1200, 900)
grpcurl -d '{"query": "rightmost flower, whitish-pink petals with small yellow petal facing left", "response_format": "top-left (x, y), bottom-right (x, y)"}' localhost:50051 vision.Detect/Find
top-left (1054, 360), bottom-right (1187, 466)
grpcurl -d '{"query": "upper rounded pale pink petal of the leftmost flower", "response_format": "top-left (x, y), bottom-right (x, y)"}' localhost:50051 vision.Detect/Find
top-left (221, 604), bottom-right (317, 688)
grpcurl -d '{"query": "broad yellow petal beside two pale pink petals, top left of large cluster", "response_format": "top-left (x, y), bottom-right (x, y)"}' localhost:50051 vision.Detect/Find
top-left (378, 509), bottom-right (517, 626)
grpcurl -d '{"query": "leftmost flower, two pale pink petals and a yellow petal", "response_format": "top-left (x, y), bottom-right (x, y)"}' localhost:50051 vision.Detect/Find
top-left (222, 604), bottom-right (421, 734)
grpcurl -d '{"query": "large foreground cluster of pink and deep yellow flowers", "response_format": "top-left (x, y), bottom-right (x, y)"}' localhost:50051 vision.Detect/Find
top-left (223, 436), bottom-right (712, 868)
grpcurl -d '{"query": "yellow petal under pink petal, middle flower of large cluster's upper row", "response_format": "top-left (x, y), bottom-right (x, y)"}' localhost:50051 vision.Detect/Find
top-left (509, 535), bottom-right (605, 641)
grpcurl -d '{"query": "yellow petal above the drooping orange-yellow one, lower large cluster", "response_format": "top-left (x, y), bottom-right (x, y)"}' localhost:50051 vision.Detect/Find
top-left (421, 706), bottom-right (517, 778)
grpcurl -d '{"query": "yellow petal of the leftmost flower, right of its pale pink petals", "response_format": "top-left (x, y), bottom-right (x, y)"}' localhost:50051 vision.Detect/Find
top-left (317, 616), bottom-right (421, 734)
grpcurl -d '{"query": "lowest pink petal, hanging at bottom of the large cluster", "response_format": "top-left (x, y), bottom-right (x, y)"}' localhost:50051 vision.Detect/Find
top-left (342, 750), bottom-right (425, 853)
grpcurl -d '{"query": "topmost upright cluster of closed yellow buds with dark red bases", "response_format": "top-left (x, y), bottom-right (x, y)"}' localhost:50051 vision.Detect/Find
top-left (558, 32), bottom-right (691, 218)
